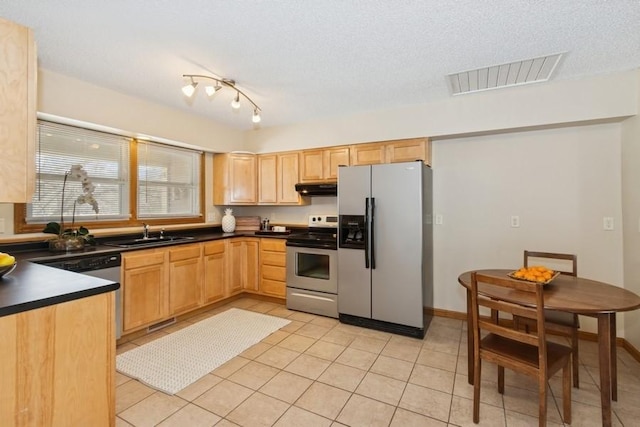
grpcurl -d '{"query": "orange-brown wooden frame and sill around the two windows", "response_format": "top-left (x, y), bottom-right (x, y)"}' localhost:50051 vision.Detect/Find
top-left (13, 132), bottom-right (206, 234)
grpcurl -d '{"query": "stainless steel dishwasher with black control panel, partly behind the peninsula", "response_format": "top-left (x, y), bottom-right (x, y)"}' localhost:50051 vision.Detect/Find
top-left (34, 254), bottom-right (122, 339)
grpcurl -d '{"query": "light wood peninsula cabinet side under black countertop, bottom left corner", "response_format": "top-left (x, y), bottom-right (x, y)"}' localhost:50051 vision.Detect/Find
top-left (0, 292), bottom-right (116, 427)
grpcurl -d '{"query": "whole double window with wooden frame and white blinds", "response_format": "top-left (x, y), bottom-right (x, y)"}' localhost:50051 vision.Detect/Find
top-left (14, 120), bottom-right (204, 233)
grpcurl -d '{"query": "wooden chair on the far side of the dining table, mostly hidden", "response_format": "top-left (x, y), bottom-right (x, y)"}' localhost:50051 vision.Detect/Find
top-left (516, 250), bottom-right (580, 388)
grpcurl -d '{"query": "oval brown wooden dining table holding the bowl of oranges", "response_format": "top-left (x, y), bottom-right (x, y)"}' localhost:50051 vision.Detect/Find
top-left (458, 269), bottom-right (640, 426)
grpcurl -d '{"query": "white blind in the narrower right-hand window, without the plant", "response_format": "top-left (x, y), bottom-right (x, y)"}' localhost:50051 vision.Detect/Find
top-left (138, 141), bottom-right (202, 219)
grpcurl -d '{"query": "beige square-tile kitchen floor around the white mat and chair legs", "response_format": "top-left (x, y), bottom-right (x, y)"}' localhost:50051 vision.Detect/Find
top-left (116, 298), bottom-right (640, 427)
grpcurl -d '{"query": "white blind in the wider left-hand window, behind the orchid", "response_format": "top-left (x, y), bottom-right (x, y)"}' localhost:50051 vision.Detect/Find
top-left (26, 121), bottom-right (130, 224)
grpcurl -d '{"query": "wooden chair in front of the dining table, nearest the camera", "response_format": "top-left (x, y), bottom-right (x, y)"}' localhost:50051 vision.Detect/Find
top-left (470, 272), bottom-right (571, 426)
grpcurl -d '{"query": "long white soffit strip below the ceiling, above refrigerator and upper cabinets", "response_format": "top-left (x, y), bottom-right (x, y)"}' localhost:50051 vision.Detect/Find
top-left (246, 72), bottom-right (638, 153)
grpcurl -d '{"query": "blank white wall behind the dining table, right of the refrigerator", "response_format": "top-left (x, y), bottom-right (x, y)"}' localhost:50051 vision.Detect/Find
top-left (433, 124), bottom-right (623, 332)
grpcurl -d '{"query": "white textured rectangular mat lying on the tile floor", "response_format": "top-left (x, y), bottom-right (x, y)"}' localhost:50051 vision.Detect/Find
top-left (116, 308), bottom-right (290, 394)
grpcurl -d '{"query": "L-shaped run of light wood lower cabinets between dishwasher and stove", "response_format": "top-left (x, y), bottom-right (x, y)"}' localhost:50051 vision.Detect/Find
top-left (121, 237), bottom-right (286, 334)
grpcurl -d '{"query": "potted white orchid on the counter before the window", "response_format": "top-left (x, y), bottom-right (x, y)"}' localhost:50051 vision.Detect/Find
top-left (42, 165), bottom-right (99, 251)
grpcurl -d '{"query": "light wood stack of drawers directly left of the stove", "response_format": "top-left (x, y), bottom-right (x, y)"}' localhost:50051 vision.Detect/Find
top-left (259, 239), bottom-right (287, 297)
